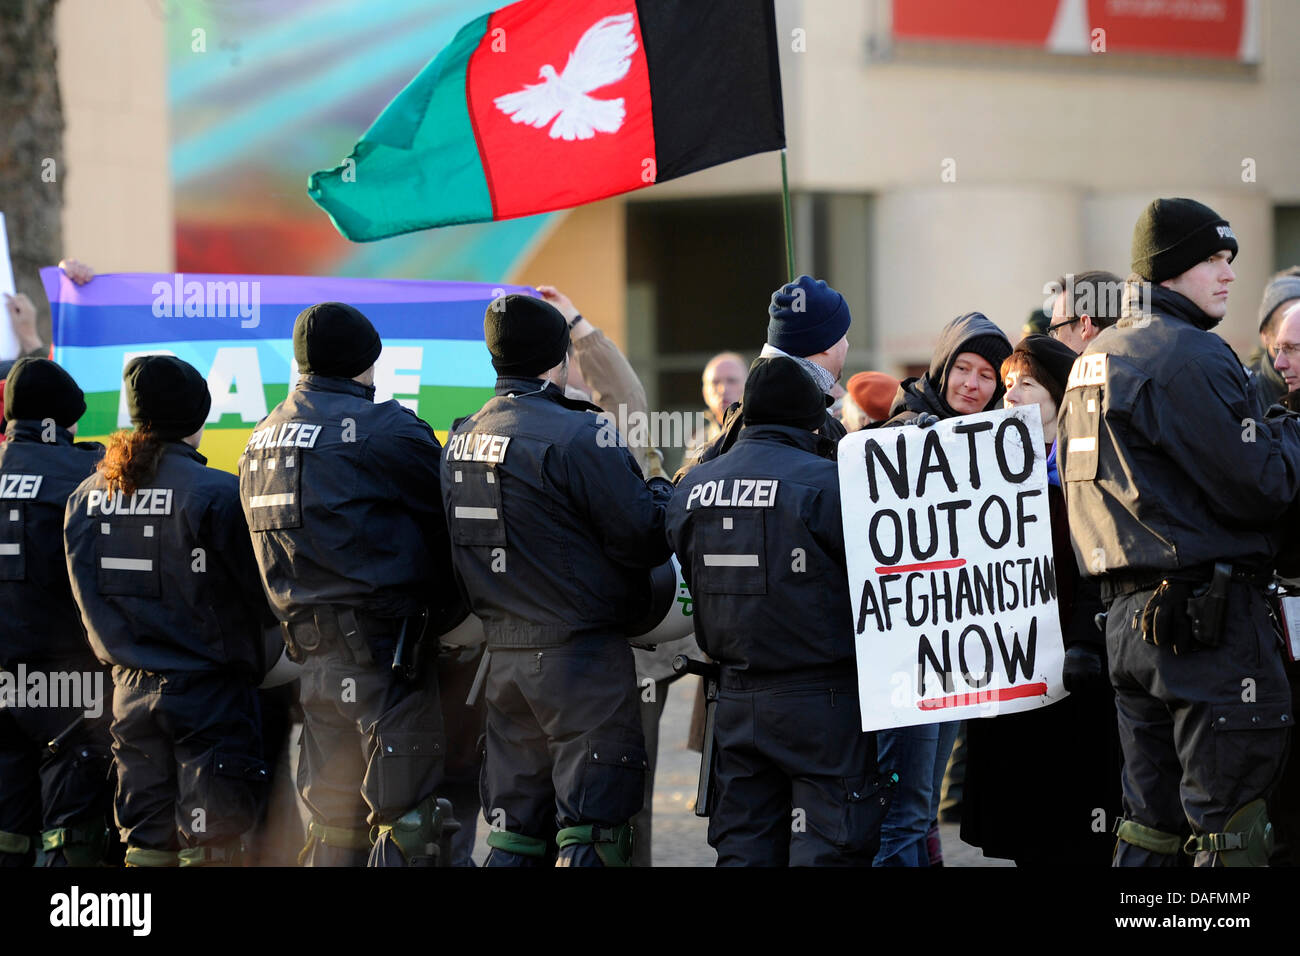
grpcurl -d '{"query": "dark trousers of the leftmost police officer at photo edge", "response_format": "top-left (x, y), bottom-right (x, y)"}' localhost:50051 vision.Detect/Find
top-left (0, 661), bottom-right (113, 866)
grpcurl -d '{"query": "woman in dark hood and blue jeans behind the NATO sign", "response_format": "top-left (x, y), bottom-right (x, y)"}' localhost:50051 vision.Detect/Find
top-left (875, 312), bottom-right (1011, 866)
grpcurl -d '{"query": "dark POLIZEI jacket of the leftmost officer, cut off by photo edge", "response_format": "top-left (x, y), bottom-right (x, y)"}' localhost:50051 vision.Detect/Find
top-left (0, 421), bottom-right (104, 665)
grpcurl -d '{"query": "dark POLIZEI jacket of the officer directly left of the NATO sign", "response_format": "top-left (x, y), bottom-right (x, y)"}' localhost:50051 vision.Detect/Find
top-left (668, 425), bottom-right (854, 676)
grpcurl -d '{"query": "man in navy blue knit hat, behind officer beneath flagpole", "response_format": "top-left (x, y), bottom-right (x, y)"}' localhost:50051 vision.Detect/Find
top-left (673, 276), bottom-right (853, 483)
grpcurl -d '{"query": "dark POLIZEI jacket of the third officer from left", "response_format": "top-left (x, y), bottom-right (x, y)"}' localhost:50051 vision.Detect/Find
top-left (239, 375), bottom-right (463, 623)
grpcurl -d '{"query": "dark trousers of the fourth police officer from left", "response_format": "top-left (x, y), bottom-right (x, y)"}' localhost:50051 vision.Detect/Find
top-left (480, 636), bottom-right (646, 866)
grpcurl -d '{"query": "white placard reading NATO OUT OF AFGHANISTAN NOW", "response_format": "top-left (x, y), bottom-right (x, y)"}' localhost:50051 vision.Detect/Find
top-left (837, 405), bottom-right (1069, 731)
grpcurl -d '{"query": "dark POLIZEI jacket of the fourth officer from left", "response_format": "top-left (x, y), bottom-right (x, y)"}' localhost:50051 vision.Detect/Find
top-left (442, 376), bottom-right (672, 649)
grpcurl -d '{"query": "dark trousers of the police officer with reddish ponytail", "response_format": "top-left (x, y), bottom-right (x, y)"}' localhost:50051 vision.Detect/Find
top-left (112, 667), bottom-right (269, 852)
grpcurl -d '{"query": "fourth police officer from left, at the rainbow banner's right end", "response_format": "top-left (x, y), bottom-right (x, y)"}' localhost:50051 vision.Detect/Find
top-left (442, 295), bottom-right (672, 866)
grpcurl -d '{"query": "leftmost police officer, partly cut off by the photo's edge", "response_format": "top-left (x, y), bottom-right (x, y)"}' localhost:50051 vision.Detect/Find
top-left (0, 358), bottom-right (113, 866)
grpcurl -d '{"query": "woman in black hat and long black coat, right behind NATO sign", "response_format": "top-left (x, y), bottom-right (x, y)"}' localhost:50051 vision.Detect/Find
top-left (962, 336), bottom-right (1121, 866)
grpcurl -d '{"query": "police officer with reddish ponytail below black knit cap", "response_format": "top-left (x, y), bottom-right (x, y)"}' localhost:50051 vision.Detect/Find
top-left (64, 355), bottom-right (270, 866)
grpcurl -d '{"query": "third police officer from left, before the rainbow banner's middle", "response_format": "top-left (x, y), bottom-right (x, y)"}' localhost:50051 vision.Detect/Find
top-left (239, 302), bottom-right (464, 866)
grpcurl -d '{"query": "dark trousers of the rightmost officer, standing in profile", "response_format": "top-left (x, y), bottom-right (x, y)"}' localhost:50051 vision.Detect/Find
top-left (1106, 581), bottom-right (1295, 866)
